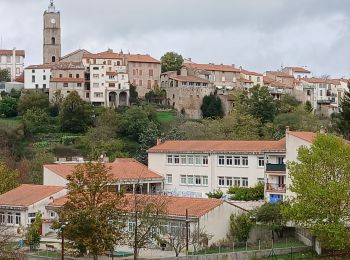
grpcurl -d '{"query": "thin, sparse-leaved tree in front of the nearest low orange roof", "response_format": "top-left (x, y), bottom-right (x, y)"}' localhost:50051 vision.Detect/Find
top-left (126, 194), bottom-right (167, 259)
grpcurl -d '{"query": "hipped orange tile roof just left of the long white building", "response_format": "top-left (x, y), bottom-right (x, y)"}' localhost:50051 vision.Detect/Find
top-left (44, 158), bottom-right (163, 181)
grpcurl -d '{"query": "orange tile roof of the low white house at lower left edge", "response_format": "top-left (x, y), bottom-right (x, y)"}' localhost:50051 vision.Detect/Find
top-left (0, 184), bottom-right (64, 207)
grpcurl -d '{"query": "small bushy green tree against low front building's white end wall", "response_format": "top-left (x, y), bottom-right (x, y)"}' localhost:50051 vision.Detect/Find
top-left (229, 213), bottom-right (254, 242)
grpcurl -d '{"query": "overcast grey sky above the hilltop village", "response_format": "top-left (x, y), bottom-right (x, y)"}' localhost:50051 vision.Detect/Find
top-left (0, 0), bottom-right (350, 77)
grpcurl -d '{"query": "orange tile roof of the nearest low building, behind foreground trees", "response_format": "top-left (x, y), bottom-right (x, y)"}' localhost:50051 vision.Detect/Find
top-left (49, 194), bottom-right (224, 218)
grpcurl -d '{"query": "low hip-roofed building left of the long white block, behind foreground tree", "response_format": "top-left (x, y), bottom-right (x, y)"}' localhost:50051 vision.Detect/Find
top-left (43, 158), bottom-right (164, 194)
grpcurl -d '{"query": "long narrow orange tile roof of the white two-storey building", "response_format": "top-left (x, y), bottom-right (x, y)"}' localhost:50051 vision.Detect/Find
top-left (148, 138), bottom-right (286, 153)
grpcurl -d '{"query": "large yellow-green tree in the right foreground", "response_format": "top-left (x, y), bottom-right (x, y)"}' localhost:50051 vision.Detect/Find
top-left (283, 134), bottom-right (350, 250)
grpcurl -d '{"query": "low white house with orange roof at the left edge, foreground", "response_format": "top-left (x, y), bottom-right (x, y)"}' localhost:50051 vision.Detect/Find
top-left (0, 184), bottom-right (66, 236)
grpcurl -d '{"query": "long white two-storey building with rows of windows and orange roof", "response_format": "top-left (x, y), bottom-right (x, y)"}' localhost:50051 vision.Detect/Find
top-left (148, 139), bottom-right (286, 197)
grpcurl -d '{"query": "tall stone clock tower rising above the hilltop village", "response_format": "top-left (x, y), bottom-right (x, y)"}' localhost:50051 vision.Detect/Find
top-left (43, 0), bottom-right (61, 64)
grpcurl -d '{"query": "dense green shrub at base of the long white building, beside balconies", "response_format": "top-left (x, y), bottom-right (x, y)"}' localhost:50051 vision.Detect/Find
top-left (227, 182), bottom-right (264, 201)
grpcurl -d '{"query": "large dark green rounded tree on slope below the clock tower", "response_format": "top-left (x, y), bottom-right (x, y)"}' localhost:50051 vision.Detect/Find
top-left (60, 91), bottom-right (93, 133)
